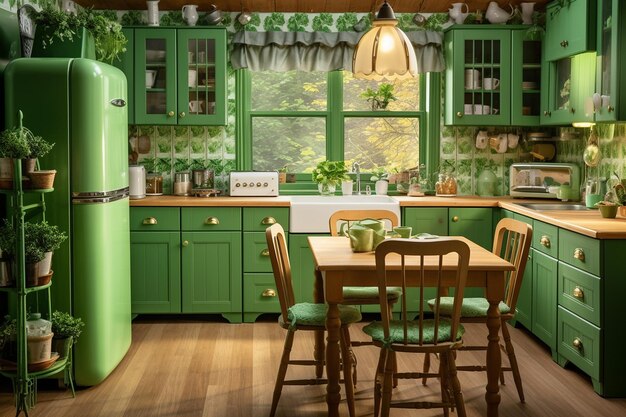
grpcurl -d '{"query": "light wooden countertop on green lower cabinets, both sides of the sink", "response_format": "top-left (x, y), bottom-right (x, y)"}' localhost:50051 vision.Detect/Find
top-left (130, 195), bottom-right (626, 239)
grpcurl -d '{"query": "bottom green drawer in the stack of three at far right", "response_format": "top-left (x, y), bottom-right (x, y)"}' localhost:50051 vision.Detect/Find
top-left (557, 306), bottom-right (601, 379)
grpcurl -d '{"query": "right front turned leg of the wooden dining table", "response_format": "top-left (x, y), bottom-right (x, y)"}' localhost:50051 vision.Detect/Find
top-left (485, 272), bottom-right (504, 417)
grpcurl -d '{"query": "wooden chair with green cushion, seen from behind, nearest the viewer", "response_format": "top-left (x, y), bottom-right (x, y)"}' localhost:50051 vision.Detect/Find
top-left (363, 239), bottom-right (470, 417)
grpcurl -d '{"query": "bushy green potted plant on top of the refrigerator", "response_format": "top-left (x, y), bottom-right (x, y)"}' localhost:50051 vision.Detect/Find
top-left (31, 2), bottom-right (127, 63)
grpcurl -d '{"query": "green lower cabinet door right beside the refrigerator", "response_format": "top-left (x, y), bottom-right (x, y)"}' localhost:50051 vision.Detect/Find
top-left (130, 232), bottom-right (181, 314)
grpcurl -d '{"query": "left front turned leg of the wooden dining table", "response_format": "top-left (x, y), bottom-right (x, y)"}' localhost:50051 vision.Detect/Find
top-left (326, 302), bottom-right (341, 417)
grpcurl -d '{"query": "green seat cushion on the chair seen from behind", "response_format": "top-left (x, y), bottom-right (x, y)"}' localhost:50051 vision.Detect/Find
top-left (363, 318), bottom-right (465, 344)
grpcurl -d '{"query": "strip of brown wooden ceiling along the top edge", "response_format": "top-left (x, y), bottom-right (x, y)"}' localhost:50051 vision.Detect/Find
top-left (70, 0), bottom-right (549, 13)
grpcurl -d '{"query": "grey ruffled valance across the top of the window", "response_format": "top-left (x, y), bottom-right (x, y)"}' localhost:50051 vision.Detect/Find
top-left (230, 31), bottom-right (445, 73)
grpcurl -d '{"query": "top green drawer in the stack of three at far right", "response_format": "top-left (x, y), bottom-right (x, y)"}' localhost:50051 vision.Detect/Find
top-left (559, 229), bottom-right (600, 275)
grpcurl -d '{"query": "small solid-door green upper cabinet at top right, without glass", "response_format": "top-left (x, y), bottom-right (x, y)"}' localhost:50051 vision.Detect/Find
top-left (544, 0), bottom-right (596, 61)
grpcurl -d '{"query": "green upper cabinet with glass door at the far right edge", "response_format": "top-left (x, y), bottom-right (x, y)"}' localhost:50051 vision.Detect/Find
top-left (591, 0), bottom-right (626, 122)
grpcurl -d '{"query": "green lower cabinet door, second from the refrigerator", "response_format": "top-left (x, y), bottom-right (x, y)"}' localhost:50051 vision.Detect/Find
top-left (181, 231), bottom-right (242, 322)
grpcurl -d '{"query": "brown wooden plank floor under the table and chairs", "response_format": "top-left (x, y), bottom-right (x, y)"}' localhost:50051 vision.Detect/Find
top-left (0, 318), bottom-right (626, 417)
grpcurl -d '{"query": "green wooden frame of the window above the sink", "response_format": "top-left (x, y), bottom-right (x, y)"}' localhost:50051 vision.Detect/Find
top-left (235, 68), bottom-right (441, 184)
